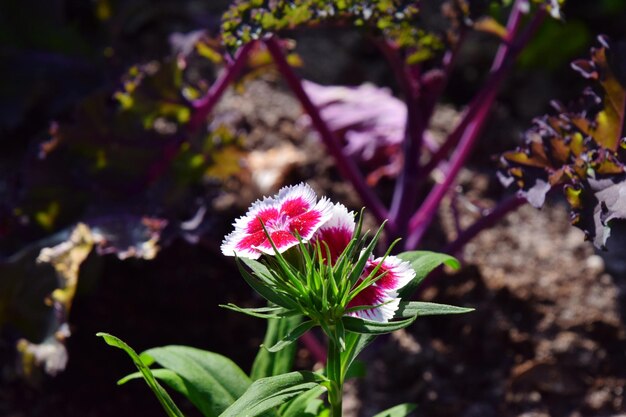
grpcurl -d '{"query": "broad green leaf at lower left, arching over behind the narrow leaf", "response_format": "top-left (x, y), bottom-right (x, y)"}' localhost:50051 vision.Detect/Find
top-left (144, 346), bottom-right (251, 417)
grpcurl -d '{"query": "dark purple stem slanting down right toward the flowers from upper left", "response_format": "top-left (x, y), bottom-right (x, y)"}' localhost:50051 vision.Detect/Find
top-left (265, 37), bottom-right (388, 223)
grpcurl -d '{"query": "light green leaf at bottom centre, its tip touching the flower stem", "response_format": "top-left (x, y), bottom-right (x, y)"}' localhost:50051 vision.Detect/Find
top-left (219, 371), bottom-right (326, 417)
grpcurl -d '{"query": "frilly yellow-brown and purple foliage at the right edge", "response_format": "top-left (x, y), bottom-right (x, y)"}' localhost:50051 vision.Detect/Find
top-left (502, 37), bottom-right (626, 247)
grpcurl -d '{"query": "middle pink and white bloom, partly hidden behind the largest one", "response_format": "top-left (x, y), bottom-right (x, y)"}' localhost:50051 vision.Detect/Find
top-left (311, 203), bottom-right (356, 265)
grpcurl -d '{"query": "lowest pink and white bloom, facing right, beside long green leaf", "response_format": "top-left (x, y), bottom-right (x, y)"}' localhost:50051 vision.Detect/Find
top-left (348, 256), bottom-right (415, 323)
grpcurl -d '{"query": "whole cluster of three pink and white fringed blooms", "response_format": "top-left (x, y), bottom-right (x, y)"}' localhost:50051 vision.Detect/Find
top-left (222, 184), bottom-right (415, 323)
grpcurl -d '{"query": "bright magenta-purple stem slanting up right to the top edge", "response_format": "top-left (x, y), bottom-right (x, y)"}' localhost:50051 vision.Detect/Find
top-left (405, 0), bottom-right (545, 249)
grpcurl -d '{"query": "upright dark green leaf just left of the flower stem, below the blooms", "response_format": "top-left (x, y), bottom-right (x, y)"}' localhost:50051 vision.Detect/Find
top-left (250, 315), bottom-right (302, 380)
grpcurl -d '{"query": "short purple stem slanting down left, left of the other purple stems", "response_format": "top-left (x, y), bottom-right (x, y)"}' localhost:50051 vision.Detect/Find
top-left (187, 42), bottom-right (255, 132)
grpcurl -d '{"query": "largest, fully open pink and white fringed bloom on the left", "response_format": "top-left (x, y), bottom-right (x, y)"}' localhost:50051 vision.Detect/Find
top-left (221, 183), bottom-right (333, 259)
